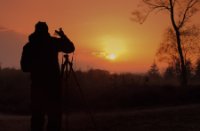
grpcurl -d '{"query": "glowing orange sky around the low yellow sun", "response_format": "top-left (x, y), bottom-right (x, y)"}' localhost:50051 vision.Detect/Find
top-left (0, 0), bottom-right (199, 72)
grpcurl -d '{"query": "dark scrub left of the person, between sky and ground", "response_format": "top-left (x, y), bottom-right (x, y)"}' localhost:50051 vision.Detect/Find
top-left (0, 68), bottom-right (30, 113)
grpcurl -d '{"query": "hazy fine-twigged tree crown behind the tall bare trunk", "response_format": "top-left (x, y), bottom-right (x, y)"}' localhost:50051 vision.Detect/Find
top-left (156, 26), bottom-right (200, 68)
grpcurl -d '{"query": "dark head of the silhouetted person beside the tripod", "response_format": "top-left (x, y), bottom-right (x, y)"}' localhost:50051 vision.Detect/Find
top-left (35, 21), bottom-right (49, 34)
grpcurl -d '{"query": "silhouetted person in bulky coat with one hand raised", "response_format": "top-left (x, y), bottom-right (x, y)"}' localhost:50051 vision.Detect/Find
top-left (21, 22), bottom-right (75, 131)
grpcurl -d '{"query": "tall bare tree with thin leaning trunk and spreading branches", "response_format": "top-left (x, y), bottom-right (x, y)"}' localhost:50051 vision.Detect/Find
top-left (132, 0), bottom-right (200, 86)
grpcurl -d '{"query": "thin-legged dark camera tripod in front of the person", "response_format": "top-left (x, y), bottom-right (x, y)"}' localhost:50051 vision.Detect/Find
top-left (61, 54), bottom-right (97, 131)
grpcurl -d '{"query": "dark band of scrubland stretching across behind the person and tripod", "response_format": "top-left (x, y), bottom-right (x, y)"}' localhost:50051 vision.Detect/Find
top-left (0, 68), bottom-right (200, 114)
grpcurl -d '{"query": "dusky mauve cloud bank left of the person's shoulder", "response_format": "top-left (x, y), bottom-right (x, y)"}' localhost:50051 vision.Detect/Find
top-left (0, 26), bottom-right (26, 68)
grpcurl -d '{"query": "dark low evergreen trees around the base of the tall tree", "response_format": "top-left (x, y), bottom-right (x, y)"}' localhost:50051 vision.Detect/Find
top-left (147, 59), bottom-right (200, 86)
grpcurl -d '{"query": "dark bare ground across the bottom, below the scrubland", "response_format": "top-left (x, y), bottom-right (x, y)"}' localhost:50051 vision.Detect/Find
top-left (0, 104), bottom-right (200, 131)
